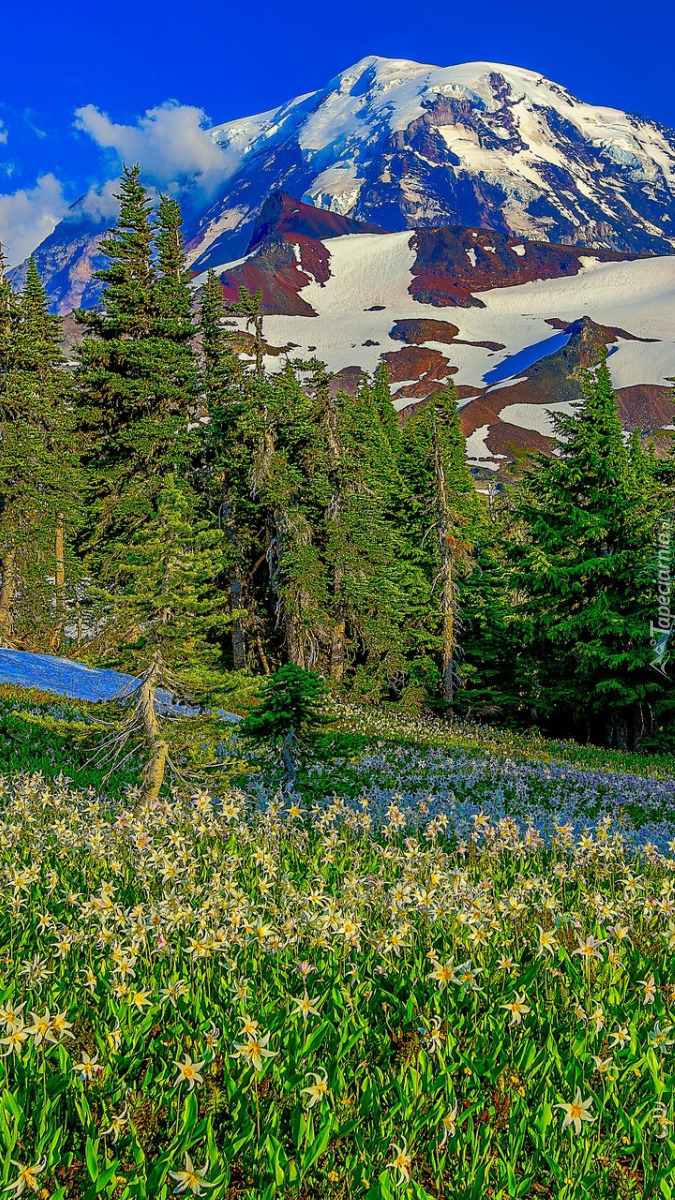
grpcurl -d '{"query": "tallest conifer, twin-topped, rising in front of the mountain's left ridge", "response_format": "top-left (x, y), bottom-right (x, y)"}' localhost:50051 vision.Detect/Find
top-left (78, 167), bottom-right (198, 609)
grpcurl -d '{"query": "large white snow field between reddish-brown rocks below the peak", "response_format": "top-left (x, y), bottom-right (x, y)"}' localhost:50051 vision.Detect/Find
top-left (258, 230), bottom-right (675, 388)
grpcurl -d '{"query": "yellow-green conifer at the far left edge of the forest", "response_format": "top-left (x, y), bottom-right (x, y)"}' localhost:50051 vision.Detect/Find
top-left (0, 258), bottom-right (80, 649)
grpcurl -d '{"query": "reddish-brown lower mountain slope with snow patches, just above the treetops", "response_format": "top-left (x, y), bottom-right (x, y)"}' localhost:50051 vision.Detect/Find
top-left (207, 222), bottom-right (675, 472)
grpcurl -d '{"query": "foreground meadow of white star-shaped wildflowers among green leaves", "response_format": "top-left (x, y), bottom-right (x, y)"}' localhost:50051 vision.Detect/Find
top-left (0, 705), bottom-right (675, 1200)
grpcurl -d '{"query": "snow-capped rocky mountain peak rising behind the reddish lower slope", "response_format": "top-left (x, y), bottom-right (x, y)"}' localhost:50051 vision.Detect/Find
top-left (18, 56), bottom-right (675, 311)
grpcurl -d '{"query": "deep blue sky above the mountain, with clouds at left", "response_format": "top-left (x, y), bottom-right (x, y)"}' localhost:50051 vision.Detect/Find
top-left (0, 0), bottom-right (675, 260)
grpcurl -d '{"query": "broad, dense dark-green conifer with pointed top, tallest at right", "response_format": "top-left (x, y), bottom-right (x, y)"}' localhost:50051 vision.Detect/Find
top-left (514, 359), bottom-right (661, 748)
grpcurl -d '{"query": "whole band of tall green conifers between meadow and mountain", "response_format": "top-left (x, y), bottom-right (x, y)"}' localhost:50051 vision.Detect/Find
top-left (0, 167), bottom-right (675, 748)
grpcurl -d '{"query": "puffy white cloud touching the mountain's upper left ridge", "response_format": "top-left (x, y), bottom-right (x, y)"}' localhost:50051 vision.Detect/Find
top-left (74, 102), bottom-right (239, 191)
